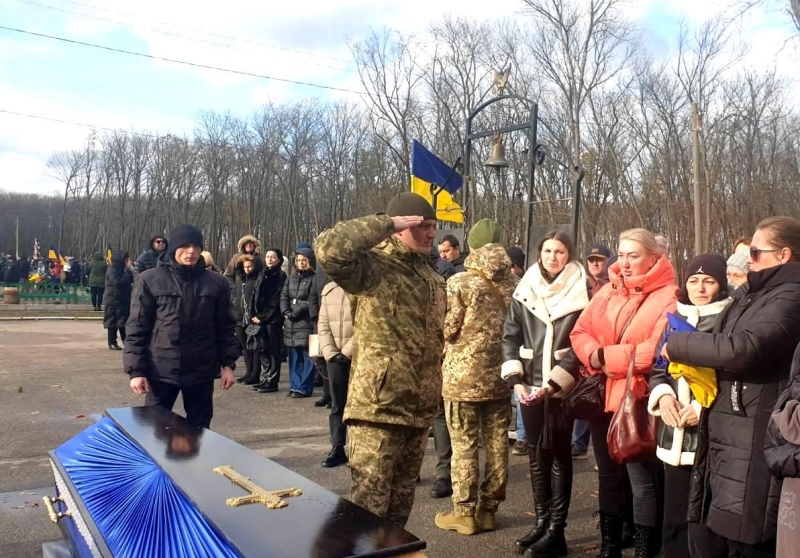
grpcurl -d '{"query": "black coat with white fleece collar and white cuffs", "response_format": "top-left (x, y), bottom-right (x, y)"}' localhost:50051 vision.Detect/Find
top-left (500, 262), bottom-right (589, 398)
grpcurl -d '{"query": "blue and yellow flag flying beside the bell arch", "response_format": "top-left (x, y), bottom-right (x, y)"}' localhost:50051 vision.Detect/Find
top-left (411, 140), bottom-right (464, 223)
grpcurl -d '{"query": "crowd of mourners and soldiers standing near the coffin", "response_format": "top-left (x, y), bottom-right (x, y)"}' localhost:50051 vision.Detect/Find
top-left (112, 193), bottom-right (800, 558)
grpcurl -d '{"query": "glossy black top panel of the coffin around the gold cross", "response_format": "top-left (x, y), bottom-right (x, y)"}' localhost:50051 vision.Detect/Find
top-left (105, 407), bottom-right (425, 558)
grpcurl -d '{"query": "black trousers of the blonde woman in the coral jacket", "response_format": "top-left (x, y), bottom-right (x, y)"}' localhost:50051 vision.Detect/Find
top-left (590, 413), bottom-right (662, 527)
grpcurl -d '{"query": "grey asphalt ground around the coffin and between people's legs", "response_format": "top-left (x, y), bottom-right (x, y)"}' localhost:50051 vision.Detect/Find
top-left (0, 321), bottom-right (630, 558)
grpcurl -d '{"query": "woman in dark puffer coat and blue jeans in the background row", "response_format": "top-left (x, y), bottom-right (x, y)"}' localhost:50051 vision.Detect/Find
top-left (281, 248), bottom-right (319, 397)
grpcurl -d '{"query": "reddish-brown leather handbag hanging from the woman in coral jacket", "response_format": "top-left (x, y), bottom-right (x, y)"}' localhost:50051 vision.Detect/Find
top-left (606, 356), bottom-right (658, 463)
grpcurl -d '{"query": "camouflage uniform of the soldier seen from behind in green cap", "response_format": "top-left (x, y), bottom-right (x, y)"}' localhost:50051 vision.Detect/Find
top-left (442, 244), bottom-right (519, 516)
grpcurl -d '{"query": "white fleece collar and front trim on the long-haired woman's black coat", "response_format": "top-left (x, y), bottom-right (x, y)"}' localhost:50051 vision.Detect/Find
top-left (512, 262), bottom-right (589, 387)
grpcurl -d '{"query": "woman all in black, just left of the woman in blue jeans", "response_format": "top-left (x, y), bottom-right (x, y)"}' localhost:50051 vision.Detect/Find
top-left (253, 248), bottom-right (286, 393)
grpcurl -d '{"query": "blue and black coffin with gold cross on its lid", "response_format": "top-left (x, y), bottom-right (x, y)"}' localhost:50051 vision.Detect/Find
top-left (45, 407), bottom-right (425, 558)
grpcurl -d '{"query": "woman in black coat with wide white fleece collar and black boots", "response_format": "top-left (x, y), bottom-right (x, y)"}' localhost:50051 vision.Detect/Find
top-left (501, 230), bottom-right (589, 557)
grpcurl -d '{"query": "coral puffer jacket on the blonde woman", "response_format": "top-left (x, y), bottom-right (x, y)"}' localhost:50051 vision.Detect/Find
top-left (570, 256), bottom-right (678, 412)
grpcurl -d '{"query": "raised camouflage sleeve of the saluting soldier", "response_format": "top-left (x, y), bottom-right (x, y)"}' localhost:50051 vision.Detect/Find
top-left (316, 215), bottom-right (394, 295)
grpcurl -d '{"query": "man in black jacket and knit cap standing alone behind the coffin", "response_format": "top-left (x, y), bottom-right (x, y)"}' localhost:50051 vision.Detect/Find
top-left (123, 225), bottom-right (242, 428)
